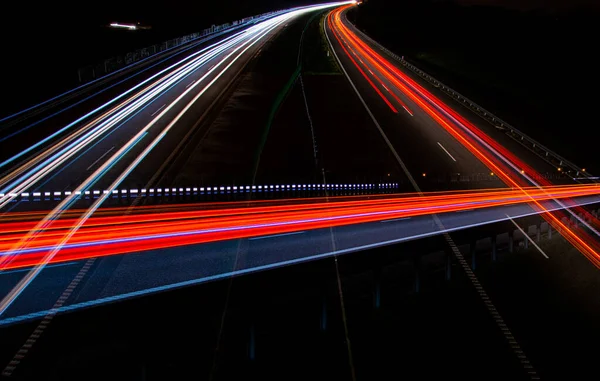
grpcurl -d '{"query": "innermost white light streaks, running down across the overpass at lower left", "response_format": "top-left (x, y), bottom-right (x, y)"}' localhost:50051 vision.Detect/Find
top-left (0, 3), bottom-right (352, 315)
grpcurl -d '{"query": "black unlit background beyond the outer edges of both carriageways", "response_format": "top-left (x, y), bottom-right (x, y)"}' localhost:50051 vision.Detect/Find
top-left (0, 0), bottom-right (600, 168)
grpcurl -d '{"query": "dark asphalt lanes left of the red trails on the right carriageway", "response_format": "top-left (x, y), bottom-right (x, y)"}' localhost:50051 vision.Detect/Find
top-left (327, 10), bottom-right (496, 190)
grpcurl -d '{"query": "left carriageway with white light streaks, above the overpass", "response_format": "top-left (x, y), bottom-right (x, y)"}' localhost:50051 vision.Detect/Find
top-left (0, 3), bottom-right (350, 211)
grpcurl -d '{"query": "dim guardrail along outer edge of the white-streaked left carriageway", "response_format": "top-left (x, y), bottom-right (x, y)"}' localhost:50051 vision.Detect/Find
top-left (77, 10), bottom-right (284, 84)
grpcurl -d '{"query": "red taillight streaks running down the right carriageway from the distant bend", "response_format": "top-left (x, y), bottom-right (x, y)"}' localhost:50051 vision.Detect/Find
top-left (328, 7), bottom-right (600, 267)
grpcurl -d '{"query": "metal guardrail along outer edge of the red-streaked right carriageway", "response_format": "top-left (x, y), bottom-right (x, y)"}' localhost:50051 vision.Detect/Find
top-left (346, 20), bottom-right (597, 180)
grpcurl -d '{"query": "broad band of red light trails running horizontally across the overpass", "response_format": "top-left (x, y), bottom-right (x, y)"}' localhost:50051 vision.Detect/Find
top-left (0, 184), bottom-right (600, 270)
